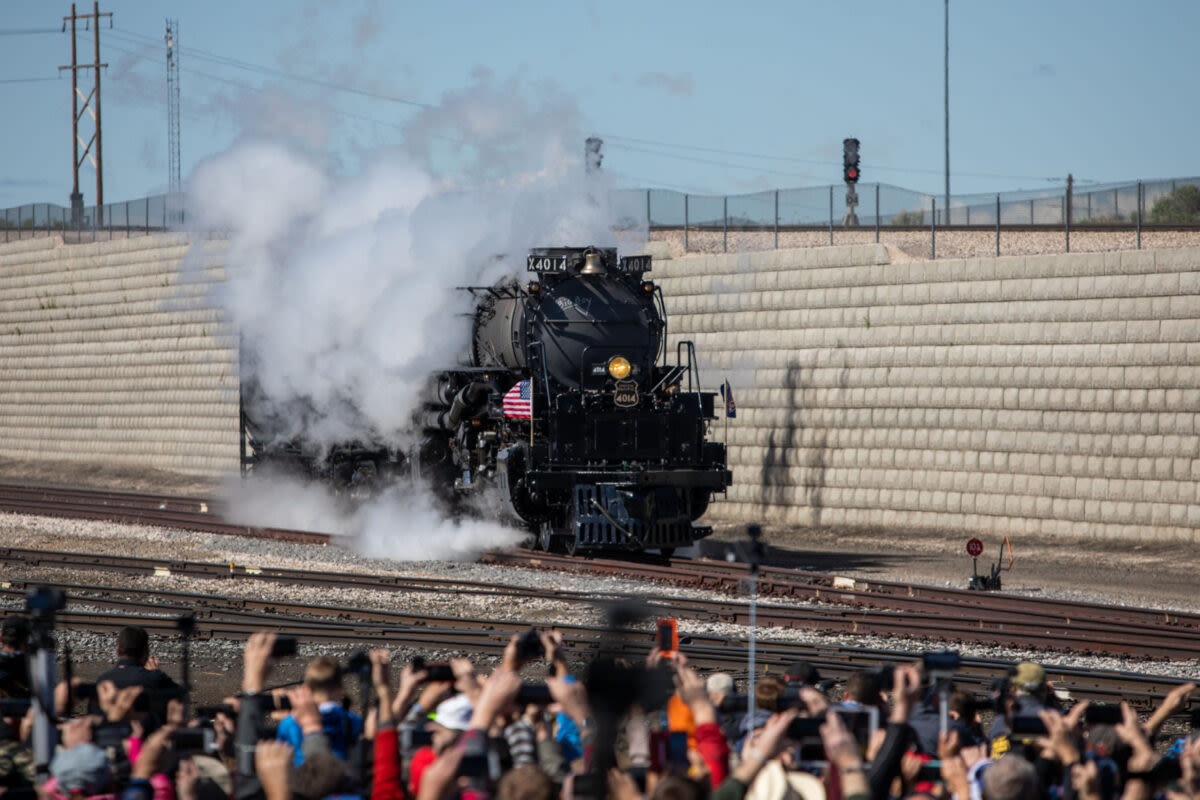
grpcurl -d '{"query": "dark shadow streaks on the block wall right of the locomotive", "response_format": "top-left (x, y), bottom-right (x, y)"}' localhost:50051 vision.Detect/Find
top-left (760, 348), bottom-right (850, 525)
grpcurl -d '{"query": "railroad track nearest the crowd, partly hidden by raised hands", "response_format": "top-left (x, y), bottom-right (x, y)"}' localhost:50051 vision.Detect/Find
top-left (0, 581), bottom-right (1181, 709)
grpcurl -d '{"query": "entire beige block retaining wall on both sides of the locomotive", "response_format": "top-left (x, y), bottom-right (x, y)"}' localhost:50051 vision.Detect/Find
top-left (0, 235), bottom-right (1200, 541)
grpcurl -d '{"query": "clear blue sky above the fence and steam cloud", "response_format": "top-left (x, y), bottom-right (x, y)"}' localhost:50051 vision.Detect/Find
top-left (0, 0), bottom-right (1200, 207)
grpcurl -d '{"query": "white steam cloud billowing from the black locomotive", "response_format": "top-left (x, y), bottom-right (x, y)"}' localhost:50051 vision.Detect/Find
top-left (188, 73), bottom-right (644, 558)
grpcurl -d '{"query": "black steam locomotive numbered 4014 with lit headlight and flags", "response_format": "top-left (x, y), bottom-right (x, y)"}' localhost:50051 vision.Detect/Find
top-left (242, 247), bottom-right (731, 554)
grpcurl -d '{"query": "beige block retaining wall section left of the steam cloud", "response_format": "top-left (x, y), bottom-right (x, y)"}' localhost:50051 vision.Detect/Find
top-left (0, 235), bottom-right (238, 476)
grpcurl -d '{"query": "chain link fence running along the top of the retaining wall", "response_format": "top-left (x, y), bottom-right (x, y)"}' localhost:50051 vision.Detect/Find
top-left (0, 178), bottom-right (1200, 258)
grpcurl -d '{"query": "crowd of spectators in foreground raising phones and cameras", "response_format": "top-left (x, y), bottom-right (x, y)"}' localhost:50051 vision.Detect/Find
top-left (0, 606), bottom-right (1200, 800)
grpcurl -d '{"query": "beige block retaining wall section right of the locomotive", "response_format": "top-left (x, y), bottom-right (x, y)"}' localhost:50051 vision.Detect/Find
top-left (654, 245), bottom-right (1200, 541)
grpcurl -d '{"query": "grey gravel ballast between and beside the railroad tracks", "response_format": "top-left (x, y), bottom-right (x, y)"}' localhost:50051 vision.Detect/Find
top-left (0, 515), bottom-right (1200, 710)
